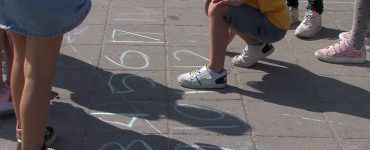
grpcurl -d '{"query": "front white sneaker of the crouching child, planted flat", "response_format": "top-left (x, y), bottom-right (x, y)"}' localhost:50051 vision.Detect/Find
top-left (177, 66), bottom-right (227, 89)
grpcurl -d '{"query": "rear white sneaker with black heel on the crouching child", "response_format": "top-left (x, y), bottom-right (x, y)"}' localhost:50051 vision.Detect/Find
top-left (232, 43), bottom-right (275, 67)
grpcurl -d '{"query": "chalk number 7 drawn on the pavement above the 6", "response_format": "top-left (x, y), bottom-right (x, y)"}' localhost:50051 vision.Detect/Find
top-left (110, 29), bottom-right (164, 44)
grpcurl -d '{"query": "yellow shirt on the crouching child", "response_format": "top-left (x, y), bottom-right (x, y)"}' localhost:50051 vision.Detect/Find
top-left (245, 0), bottom-right (290, 29)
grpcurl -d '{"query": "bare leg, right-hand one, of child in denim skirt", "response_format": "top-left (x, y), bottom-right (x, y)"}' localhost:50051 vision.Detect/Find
top-left (12, 33), bottom-right (62, 150)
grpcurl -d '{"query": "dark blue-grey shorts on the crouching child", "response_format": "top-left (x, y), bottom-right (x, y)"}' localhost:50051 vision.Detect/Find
top-left (226, 5), bottom-right (287, 43)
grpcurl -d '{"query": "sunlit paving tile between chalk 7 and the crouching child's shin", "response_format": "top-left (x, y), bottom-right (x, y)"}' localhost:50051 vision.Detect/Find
top-left (166, 26), bottom-right (209, 46)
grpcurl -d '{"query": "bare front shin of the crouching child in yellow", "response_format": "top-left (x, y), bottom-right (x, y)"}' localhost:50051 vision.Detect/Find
top-left (208, 2), bottom-right (229, 73)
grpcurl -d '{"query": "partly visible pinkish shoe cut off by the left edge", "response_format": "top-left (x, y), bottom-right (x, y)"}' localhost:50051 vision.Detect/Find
top-left (0, 86), bottom-right (14, 116)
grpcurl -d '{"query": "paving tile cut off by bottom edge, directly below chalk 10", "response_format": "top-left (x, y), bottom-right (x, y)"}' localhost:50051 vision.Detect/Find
top-left (169, 135), bottom-right (254, 150)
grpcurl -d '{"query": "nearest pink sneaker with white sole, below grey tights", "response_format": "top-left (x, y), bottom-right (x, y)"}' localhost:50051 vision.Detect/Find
top-left (315, 40), bottom-right (366, 63)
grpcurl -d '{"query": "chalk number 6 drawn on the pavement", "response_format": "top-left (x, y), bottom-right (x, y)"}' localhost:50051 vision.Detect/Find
top-left (104, 50), bottom-right (149, 70)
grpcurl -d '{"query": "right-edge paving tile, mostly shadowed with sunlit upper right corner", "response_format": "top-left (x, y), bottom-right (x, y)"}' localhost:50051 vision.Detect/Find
top-left (309, 76), bottom-right (370, 103)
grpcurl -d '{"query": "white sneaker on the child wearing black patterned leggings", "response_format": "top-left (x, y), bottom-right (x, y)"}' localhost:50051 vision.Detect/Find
top-left (294, 10), bottom-right (321, 37)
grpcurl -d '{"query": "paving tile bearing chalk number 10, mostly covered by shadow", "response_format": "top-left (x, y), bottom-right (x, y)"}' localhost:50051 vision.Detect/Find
top-left (168, 99), bottom-right (251, 136)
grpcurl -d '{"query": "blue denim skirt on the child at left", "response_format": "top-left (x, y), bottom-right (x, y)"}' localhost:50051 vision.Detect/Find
top-left (0, 0), bottom-right (91, 38)
